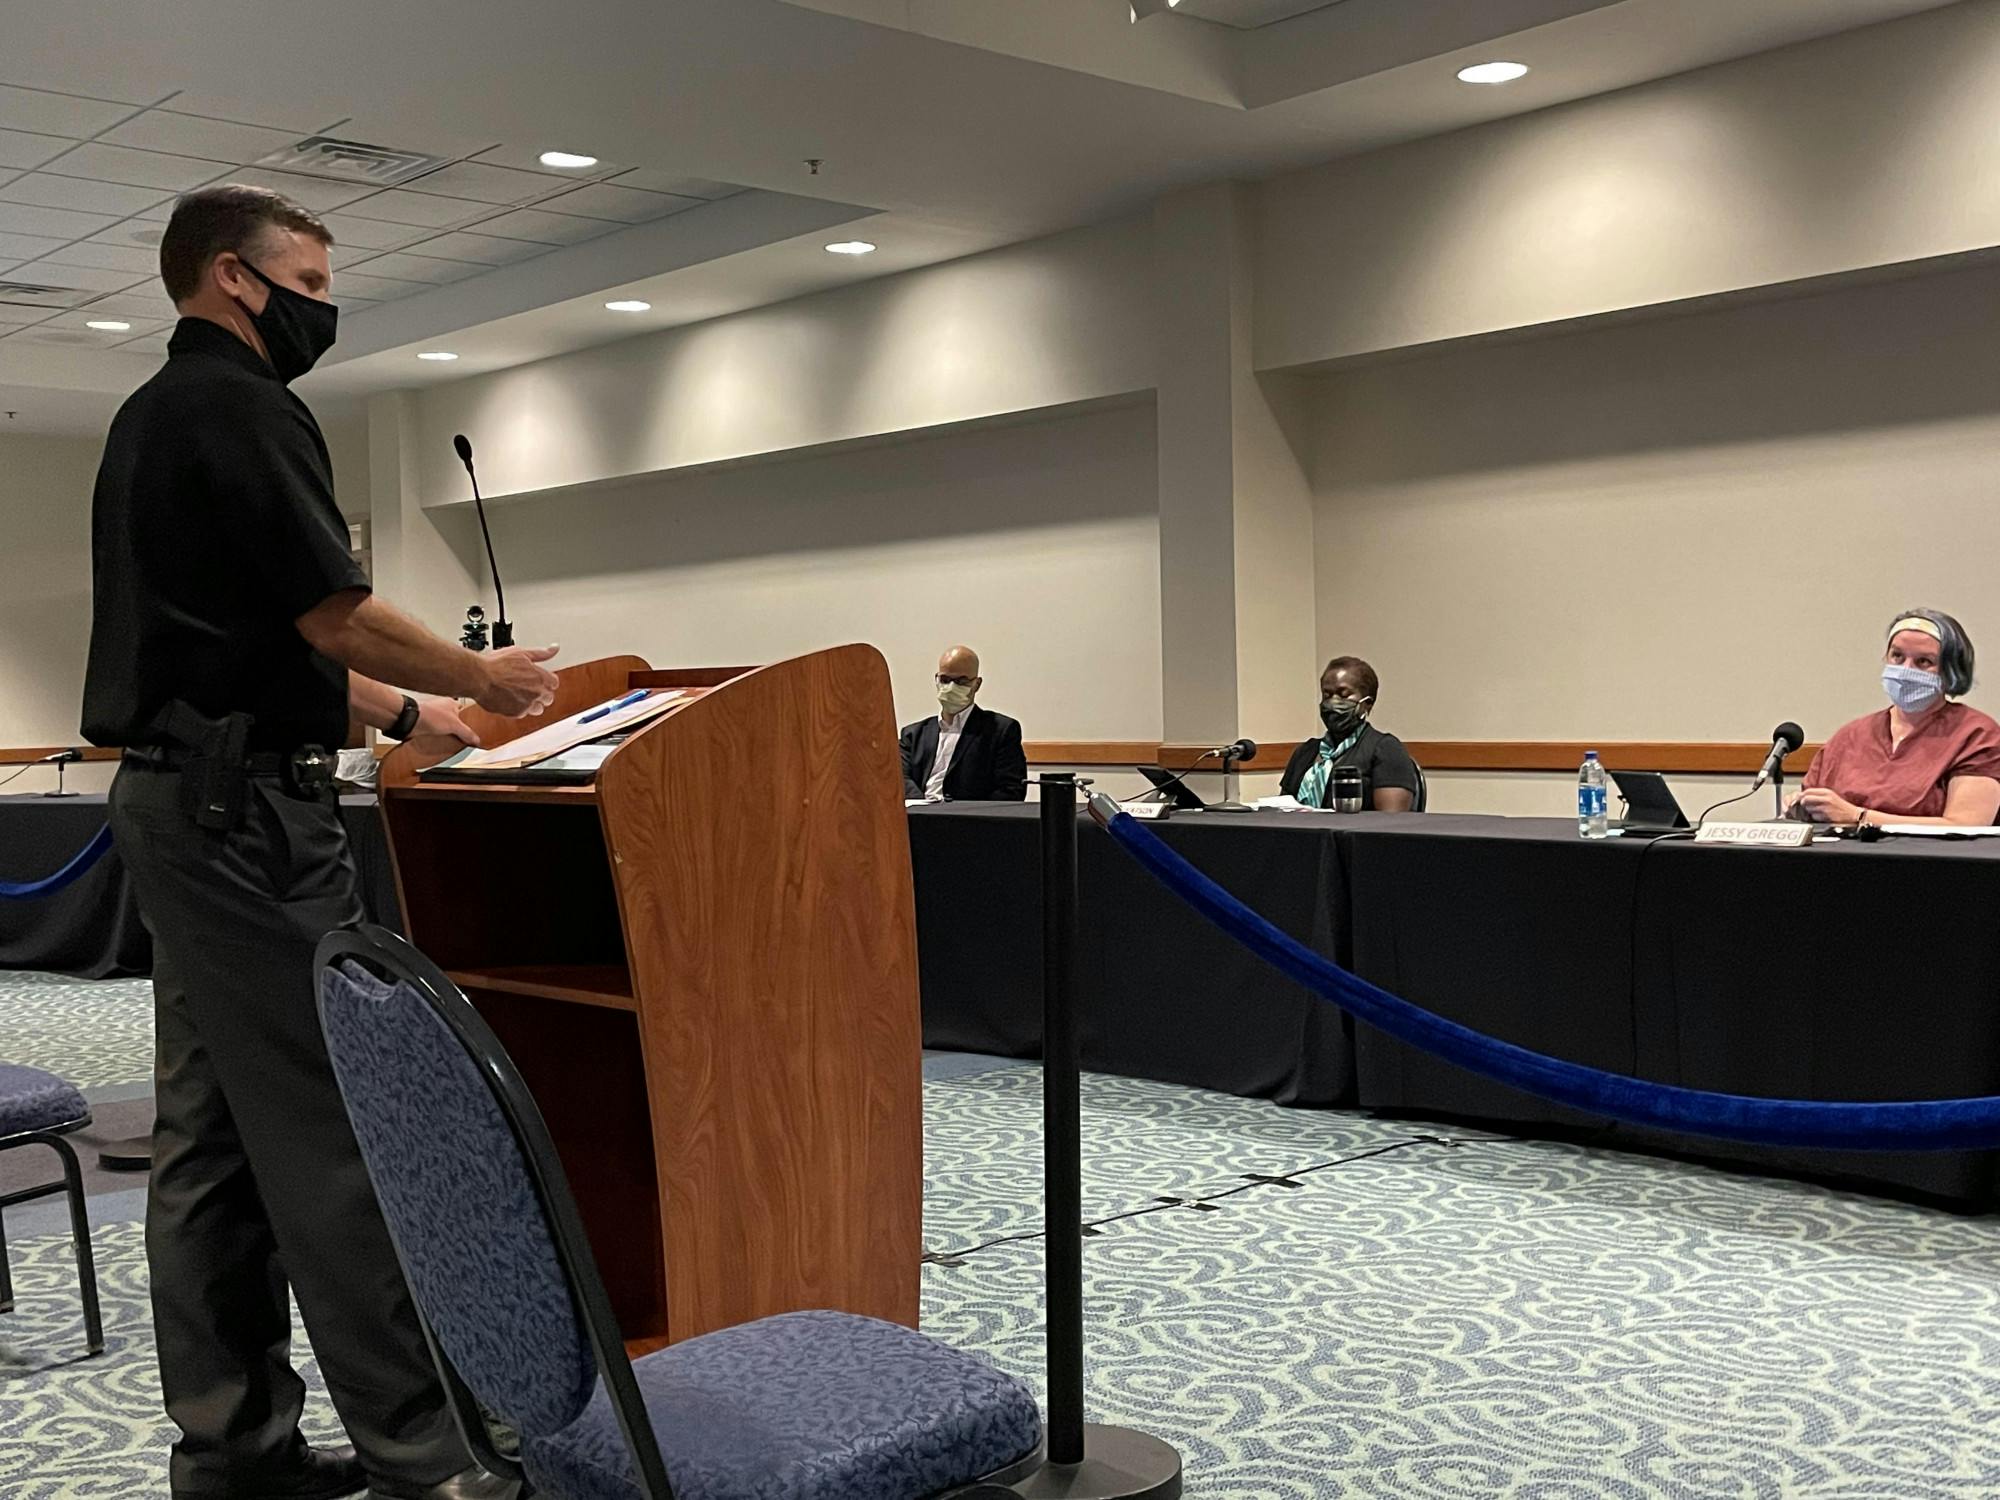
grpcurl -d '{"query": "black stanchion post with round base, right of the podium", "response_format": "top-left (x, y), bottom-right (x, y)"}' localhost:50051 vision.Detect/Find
top-left (1008, 772), bottom-right (1180, 1500)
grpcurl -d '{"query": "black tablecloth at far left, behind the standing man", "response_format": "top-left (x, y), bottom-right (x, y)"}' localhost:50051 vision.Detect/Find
top-left (0, 792), bottom-right (402, 980)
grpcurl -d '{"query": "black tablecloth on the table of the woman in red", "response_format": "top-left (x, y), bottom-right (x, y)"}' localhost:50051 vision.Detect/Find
top-left (1342, 818), bottom-right (2000, 1206)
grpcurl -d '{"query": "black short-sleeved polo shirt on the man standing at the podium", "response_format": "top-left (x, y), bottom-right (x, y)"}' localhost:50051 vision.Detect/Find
top-left (84, 318), bottom-right (368, 750)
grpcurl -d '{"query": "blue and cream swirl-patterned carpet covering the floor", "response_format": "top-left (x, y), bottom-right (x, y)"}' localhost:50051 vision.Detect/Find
top-left (0, 976), bottom-right (2000, 1500)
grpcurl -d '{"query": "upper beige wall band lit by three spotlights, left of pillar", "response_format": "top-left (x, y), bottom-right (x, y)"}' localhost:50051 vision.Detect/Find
top-left (416, 220), bottom-right (1154, 506)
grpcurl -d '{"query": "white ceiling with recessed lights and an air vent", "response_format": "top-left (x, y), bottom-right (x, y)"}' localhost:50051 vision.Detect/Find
top-left (0, 0), bottom-right (1990, 432)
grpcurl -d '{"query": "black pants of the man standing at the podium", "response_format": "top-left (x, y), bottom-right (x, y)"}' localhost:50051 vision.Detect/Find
top-left (110, 762), bottom-right (470, 1496)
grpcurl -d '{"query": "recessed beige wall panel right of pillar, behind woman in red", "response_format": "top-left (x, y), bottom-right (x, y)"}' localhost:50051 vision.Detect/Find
top-left (1302, 256), bottom-right (2000, 810)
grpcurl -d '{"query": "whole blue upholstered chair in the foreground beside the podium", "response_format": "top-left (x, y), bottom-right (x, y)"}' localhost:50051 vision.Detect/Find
top-left (318, 928), bottom-right (1042, 1500)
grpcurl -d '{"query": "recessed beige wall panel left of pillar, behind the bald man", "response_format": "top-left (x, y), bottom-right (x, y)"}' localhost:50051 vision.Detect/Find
top-left (466, 402), bottom-right (1160, 740)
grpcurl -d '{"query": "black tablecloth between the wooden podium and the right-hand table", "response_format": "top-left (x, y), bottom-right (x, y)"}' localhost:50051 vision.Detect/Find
top-left (910, 802), bottom-right (1354, 1104)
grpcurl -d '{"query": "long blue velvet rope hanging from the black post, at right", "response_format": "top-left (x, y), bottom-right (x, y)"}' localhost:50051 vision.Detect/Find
top-left (1104, 812), bottom-right (2000, 1152)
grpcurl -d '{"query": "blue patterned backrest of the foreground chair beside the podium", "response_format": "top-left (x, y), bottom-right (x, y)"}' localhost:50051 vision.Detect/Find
top-left (318, 926), bottom-right (672, 1500)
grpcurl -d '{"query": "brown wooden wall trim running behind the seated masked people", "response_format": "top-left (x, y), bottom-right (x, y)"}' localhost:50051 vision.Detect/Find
top-left (1024, 740), bottom-right (1820, 776)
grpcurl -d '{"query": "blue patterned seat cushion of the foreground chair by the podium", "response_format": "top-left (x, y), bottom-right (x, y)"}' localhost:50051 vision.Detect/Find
top-left (522, 1312), bottom-right (1042, 1500)
